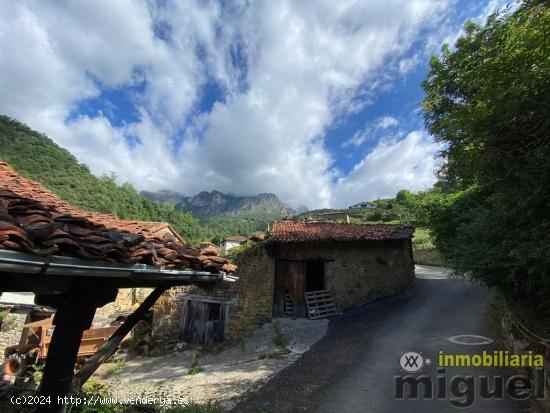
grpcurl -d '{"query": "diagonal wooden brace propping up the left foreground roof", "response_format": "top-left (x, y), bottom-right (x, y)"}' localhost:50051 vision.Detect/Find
top-left (72, 286), bottom-right (168, 392)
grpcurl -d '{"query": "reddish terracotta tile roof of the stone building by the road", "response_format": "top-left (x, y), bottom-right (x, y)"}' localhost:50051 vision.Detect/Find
top-left (268, 220), bottom-right (413, 243)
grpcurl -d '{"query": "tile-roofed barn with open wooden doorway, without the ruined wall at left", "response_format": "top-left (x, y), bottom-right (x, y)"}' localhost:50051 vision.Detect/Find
top-left (265, 221), bottom-right (414, 318)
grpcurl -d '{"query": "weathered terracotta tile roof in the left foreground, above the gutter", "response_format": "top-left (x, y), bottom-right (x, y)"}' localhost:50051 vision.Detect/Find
top-left (0, 160), bottom-right (236, 272)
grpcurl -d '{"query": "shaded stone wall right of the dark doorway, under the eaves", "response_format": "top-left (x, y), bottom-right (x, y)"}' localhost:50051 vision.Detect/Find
top-left (276, 240), bottom-right (415, 310)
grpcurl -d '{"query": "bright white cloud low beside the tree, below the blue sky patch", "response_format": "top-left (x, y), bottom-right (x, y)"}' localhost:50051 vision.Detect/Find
top-left (333, 131), bottom-right (441, 207)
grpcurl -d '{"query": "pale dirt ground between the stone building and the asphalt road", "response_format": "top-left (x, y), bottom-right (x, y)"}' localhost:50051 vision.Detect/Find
top-left (97, 318), bottom-right (328, 409)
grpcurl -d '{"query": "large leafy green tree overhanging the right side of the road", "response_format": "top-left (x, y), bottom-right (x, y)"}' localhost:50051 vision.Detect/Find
top-left (423, 0), bottom-right (550, 319)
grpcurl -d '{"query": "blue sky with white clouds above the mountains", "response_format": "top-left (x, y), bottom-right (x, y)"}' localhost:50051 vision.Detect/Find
top-left (0, 0), bottom-right (505, 209)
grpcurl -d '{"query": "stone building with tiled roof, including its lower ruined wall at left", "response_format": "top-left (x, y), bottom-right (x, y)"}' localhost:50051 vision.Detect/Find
top-left (155, 220), bottom-right (414, 339)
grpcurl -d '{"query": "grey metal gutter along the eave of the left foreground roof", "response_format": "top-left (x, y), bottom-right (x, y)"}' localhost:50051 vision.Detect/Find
top-left (0, 250), bottom-right (223, 281)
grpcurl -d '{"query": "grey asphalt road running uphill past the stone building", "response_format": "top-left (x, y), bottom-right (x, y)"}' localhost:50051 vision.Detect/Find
top-left (233, 266), bottom-right (529, 413)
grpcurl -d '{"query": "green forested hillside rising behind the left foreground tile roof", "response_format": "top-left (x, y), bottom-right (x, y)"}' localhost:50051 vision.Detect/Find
top-left (0, 116), bottom-right (213, 242)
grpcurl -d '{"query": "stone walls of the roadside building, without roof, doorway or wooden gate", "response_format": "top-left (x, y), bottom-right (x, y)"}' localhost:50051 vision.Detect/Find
top-left (153, 240), bottom-right (415, 340)
